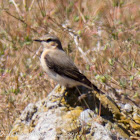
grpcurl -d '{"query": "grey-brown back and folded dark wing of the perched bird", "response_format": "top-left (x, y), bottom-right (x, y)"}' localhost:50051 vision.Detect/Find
top-left (45, 51), bottom-right (98, 90)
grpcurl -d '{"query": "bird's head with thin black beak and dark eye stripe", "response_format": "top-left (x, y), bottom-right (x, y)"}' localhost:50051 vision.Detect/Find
top-left (33, 35), bottom-right (63, 50)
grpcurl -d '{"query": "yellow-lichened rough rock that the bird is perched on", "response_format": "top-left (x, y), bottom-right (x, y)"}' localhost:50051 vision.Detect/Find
top-left (6, 85), bottom-right (139, 140)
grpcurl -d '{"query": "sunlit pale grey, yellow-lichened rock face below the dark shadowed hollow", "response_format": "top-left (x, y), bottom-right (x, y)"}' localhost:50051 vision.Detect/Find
top-left (7, 85), bottom-right (133, 140)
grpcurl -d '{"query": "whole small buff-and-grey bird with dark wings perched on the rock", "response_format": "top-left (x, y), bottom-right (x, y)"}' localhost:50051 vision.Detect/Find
top-left (34, 35), bottom-right (99, 91)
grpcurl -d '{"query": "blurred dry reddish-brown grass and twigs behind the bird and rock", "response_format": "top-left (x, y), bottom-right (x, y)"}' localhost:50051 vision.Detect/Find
top-left (0, 0), bottom-right (140, 139)
